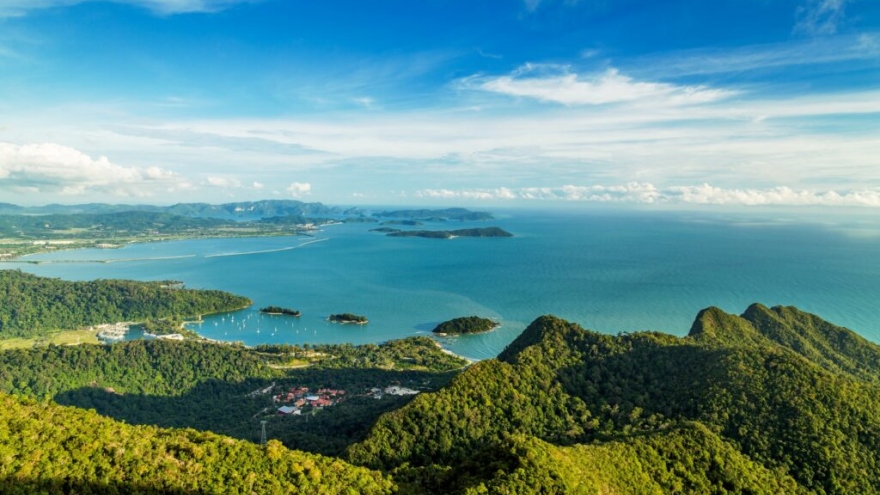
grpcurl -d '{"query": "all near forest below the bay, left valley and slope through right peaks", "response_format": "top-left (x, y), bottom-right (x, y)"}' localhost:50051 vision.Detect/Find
top-left (0, 298), bottom-right (880, 494)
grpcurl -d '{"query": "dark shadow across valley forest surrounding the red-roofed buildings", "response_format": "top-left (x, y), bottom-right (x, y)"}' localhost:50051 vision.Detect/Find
top-left (54, 369), bottom-right (453, 456)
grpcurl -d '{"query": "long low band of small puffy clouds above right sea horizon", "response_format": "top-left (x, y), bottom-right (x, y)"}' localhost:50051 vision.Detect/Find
top-left (415, 182), bottom-right (880, 208)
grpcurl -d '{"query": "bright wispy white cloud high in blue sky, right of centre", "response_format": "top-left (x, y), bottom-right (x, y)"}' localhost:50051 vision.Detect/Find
top-left (462, 64), bottom-right (735, 105)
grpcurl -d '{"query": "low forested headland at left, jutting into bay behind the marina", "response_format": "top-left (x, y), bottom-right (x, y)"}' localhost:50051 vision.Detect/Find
top-left (0, 270), bottom-right (251, 338)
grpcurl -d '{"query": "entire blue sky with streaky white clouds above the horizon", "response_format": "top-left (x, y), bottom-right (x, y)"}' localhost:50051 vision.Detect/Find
top-left (0, 0), bottom-right (880, 208)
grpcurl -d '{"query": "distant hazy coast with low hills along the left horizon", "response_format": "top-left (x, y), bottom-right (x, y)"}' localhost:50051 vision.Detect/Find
top-left (0, 200), bottom-right (495, 263)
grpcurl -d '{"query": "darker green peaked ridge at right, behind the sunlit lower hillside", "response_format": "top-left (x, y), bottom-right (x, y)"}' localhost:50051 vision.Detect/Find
top-left (347, 305), bottom-right (880, 493)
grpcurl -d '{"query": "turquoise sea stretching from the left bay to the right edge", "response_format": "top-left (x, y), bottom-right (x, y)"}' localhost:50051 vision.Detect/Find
top-left (7, 211), bottom-right (880, 359)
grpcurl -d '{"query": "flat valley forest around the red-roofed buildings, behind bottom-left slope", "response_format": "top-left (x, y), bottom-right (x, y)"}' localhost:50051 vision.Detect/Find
top-left (0, 337), bottom-right (467, 455)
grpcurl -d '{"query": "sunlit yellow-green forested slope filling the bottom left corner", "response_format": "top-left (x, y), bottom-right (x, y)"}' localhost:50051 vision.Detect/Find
top-left (0, 394), bottom-right (394, 495)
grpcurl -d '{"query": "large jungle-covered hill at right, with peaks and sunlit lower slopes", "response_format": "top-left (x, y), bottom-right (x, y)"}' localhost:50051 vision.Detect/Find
top-left (348, 305), bottom-right (880, 494)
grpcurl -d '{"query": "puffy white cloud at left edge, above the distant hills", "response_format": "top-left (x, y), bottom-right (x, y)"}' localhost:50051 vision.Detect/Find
top-left (0, 143), bottom-right (182, 196)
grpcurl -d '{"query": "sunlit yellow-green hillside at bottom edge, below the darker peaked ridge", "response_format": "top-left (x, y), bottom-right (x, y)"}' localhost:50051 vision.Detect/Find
top-left (406, 423), bottom-right (804, 495)
